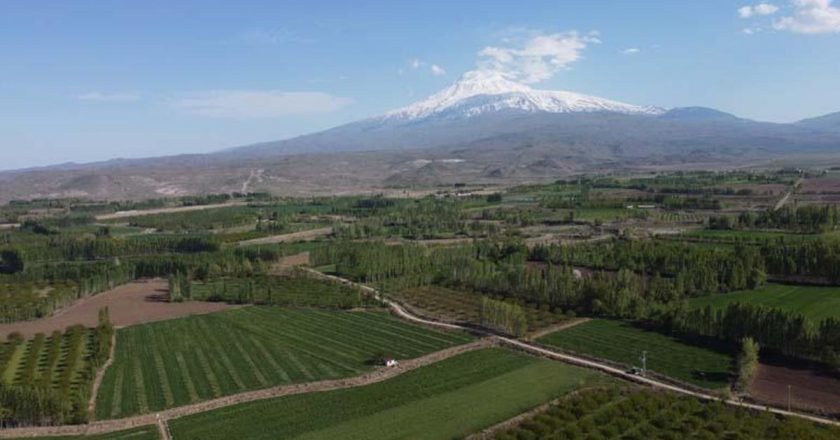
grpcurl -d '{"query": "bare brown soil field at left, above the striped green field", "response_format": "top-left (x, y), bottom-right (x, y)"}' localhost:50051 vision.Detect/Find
top-left (0, 279), bottom-right (232, 338)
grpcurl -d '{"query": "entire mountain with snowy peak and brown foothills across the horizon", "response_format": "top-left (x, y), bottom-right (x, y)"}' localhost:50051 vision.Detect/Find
top-left (0, 71), bottom-right (840, 202)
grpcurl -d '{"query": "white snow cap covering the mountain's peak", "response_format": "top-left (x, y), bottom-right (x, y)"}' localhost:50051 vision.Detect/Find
top-left (381, 70), bottom-right (664, 121)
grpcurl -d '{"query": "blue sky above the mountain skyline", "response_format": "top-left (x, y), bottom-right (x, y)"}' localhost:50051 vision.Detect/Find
top-left (0, 0), bottom-right (840, 169)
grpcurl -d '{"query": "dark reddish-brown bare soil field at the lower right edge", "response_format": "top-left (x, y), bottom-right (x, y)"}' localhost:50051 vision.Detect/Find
top-left (750, 364), bottom-right (840, 415)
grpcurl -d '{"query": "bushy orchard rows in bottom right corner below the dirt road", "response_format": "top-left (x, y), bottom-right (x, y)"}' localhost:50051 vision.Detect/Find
top-left (495, 388), bottom-right (840, 440)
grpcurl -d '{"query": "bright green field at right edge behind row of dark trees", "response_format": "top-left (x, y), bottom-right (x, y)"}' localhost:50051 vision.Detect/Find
top-left (689, 284), bottom-right (840, 321)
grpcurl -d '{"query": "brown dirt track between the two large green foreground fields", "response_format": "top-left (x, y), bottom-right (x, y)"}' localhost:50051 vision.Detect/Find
top-left (0, 337), bottom-right (498, 439)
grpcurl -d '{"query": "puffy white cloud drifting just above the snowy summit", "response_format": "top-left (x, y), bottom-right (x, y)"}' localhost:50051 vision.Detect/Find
top-left (478, 31), bottom-right (600, 83)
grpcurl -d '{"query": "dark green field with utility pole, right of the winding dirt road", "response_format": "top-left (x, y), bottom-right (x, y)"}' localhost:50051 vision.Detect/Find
top-left (539, 319), bottom-right (733, 389)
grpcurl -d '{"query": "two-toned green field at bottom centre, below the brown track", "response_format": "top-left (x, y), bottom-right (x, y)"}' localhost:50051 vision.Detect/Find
top-left (170, 349), bottom-right (603, 440)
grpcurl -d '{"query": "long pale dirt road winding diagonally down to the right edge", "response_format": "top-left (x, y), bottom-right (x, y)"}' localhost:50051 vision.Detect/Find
top-left (300, 269), bottom-right (840, 426)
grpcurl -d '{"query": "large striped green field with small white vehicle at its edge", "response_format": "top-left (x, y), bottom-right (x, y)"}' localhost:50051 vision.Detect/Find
top-left (96, 307), bottom-right (471, 419)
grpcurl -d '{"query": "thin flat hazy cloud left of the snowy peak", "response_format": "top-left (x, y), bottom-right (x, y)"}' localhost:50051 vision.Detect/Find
top-left (172, 90), bottom-right (353, 119)
